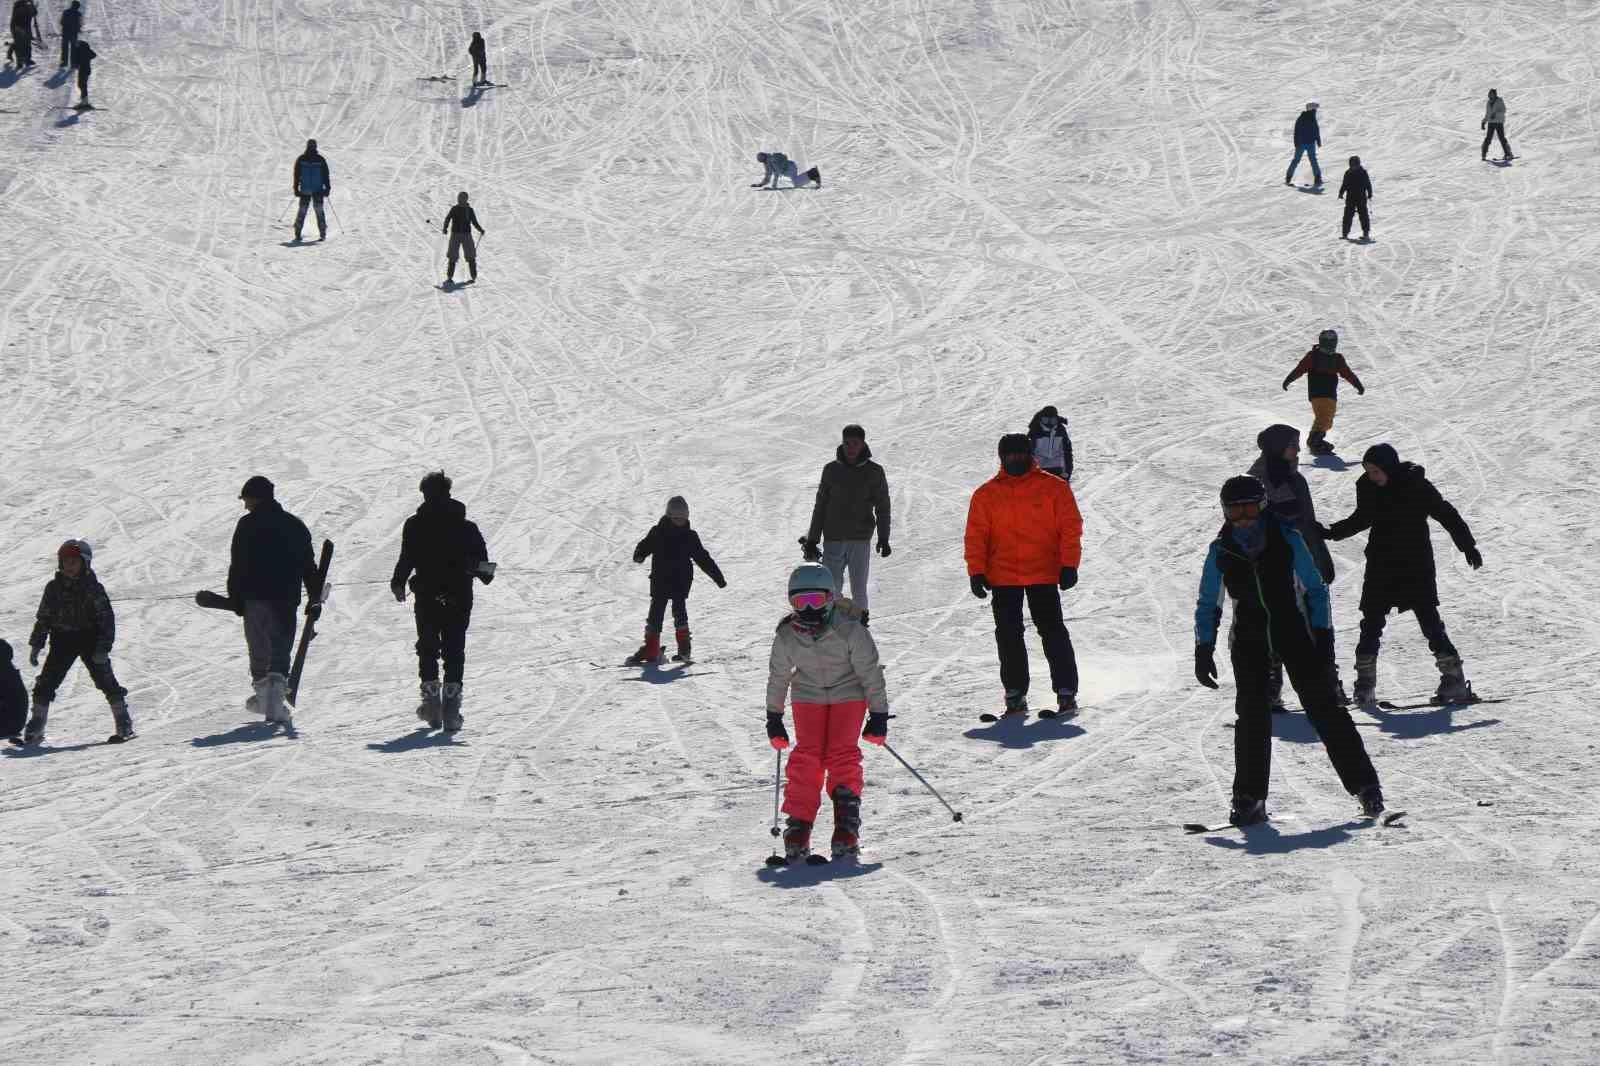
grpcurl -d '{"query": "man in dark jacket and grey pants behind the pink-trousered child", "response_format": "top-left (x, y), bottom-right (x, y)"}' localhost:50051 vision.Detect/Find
top-left (800, 423), bottom-right (891, 626)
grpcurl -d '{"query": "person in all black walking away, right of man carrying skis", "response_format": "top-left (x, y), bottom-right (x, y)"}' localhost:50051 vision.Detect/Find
top-left (389, 471), bottom-right (494, 733)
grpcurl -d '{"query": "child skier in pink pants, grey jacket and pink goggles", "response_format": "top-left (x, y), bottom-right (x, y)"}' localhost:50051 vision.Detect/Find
top-left (766, 562), bottom-right (890, 863)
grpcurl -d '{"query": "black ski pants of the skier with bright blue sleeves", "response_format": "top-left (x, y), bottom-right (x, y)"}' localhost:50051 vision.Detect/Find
top-left (1229, 634), bottom-right (1378, 799)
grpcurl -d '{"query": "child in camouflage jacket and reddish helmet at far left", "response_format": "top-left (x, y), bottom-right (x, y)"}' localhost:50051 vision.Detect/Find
top-left (22, 539), bottom-right (134, 744)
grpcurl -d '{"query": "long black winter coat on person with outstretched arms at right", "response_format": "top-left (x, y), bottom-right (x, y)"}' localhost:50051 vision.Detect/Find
top-left (1328, 463), bottom-right (1477, 613)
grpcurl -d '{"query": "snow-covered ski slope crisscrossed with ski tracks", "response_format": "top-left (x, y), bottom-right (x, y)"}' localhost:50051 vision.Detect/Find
top-left (0, 0), bottom-right (1600, 1066)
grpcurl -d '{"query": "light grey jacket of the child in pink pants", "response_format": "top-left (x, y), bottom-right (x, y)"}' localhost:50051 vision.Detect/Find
top-left (766, 600), bottom-right (890, 714)
